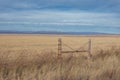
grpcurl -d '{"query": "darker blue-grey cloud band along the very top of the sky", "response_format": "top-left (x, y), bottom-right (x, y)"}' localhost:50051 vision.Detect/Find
top-left (0, 0), bottom-right (120, 13)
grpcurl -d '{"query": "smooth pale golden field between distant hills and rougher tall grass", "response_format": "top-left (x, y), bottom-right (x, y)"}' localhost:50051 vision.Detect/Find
top-left (0, 34), bottom-right (120, 51)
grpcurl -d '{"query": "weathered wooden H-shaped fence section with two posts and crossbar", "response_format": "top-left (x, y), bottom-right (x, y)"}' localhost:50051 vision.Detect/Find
top-left (58, 38), bottom-right (92, 58)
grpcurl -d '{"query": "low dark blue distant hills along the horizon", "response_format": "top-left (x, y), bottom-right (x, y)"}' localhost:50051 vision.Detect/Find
top-left (0, 31), bottom-right (108, 35)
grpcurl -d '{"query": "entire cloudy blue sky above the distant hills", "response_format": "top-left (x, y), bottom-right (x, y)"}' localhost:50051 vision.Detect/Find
top-left (0, 0), bottom-right (120, 34)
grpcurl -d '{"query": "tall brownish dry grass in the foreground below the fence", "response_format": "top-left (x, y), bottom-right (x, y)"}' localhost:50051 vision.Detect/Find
top-left (0, 48), bottom-right (120, 80)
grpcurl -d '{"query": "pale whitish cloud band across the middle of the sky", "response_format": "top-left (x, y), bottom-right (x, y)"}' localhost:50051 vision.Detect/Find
top-left (0, 10), bottom-right (120, 27)
